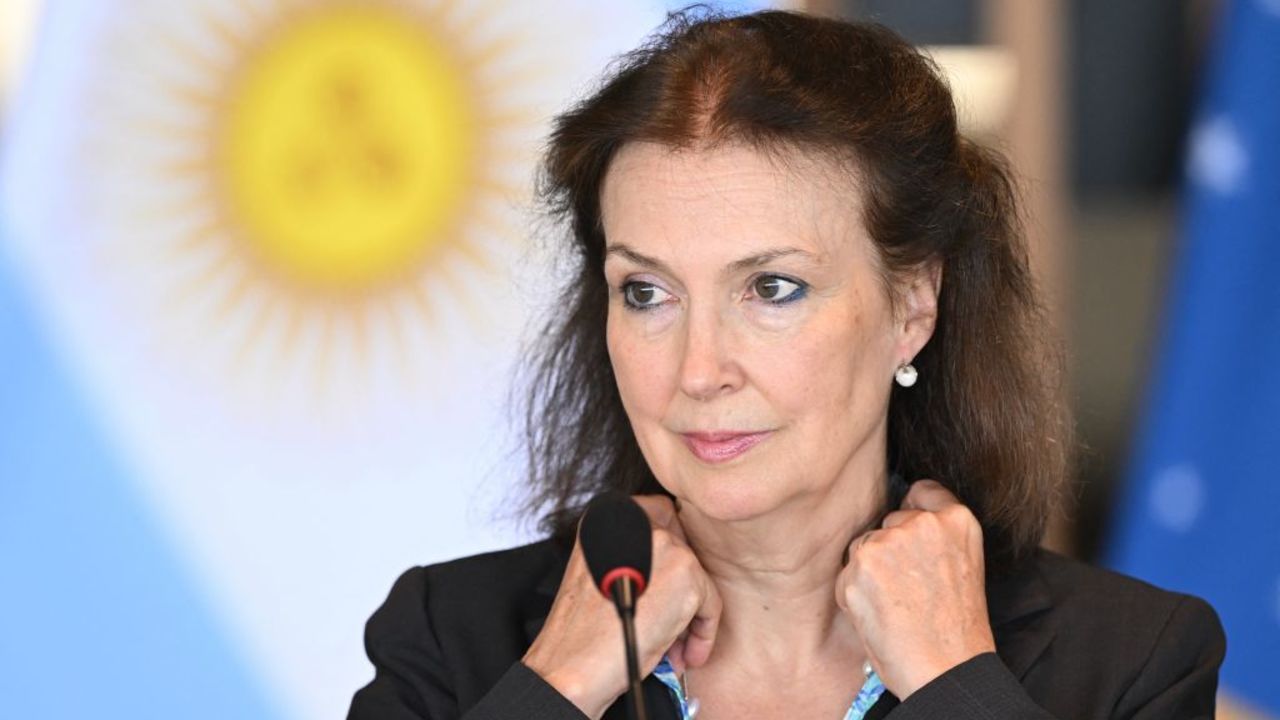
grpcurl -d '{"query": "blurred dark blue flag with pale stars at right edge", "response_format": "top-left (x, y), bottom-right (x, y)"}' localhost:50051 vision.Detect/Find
top-left (1110, 0), bottom-right (1280, 714)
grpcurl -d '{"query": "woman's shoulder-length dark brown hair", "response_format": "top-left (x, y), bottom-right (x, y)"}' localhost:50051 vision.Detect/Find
top-left (525, 12), bottom-right (1071, 574)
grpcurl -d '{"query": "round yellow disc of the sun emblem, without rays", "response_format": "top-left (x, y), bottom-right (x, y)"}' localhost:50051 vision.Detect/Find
top-left (216, 5), bottom-right (477, 292)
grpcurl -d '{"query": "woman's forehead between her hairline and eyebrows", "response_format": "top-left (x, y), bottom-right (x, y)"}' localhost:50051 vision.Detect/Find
top-left (600, 142), bottom-right (865, 255)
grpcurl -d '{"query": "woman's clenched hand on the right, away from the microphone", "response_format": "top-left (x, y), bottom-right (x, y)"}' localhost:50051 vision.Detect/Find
top-left (836, 480), bottom-right (996, 700)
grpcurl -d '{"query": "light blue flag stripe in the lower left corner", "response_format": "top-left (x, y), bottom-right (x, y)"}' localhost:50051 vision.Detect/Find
top-left (0, 220), bottom-right (290, 720)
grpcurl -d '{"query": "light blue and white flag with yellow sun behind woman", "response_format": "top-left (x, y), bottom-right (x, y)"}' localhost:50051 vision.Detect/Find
top-left (0, 0), bottom-right (701, 720)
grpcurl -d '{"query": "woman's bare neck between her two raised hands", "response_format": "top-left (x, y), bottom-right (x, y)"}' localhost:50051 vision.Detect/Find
top-left (681, 458), bottom-right (888, 673)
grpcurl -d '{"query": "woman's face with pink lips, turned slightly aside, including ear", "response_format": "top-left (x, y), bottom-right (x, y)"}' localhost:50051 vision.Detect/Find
top-left (602, 143), bottom-right (937, 520)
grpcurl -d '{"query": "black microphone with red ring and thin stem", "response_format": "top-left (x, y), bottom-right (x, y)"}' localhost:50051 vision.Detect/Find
top-left (577, 495), bottom-right (653, 720)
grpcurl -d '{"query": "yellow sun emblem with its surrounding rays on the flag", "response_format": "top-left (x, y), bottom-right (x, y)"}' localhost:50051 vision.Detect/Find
top-left (83, 0), bottom-right (545, 409)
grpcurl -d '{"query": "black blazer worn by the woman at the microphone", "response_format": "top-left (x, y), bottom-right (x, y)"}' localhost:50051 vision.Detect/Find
top-left (348, 541), bottom-right (1226, 720)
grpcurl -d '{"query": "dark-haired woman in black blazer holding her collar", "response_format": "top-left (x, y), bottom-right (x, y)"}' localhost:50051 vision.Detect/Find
top-left (351, 12), bottom-right (1224, 720)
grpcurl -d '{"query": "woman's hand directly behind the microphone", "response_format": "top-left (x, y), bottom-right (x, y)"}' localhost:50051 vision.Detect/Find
top-left (524, 496), bottom-right (721, 717)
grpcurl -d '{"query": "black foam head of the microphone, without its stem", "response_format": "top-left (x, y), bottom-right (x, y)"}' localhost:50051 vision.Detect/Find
top-left (577, 495), bottom-right (653, 598)
